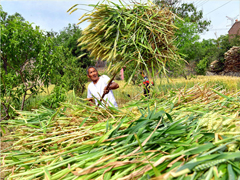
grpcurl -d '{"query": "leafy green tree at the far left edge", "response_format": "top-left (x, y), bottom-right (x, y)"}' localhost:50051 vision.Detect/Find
top-left (0, 8), bottom-right (61, 119)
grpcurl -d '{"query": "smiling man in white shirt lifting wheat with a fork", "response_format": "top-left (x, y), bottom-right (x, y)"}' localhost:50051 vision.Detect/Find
top-left (87, 66), bottom-right (119, 107)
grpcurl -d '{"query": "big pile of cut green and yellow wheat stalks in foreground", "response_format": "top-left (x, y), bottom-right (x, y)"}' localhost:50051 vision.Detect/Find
top-left (1, 85), bottom-right (240, 180)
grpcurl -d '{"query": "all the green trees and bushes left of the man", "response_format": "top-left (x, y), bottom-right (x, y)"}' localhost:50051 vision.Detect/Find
top-left (0, 7), bottom-right (92, 119)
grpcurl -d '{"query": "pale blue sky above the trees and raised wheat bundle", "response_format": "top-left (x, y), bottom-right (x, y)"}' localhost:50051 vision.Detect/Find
top-left (0, 0), bottom-right (240, 40)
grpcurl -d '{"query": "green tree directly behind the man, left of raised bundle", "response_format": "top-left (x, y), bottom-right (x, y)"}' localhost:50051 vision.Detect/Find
top-left (48, 24), bottom-right (93, 95)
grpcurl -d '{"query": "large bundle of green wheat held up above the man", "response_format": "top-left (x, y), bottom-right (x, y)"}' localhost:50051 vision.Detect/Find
top-left (69, 1), bottom-right (182, 74)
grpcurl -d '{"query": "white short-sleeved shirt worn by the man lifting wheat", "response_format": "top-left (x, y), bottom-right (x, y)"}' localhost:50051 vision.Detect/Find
top-left (87, 75), bottom-right (118, 107)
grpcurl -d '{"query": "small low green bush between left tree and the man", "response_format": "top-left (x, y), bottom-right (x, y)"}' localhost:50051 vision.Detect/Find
top-left (40, 86), bottom-right (67, 108)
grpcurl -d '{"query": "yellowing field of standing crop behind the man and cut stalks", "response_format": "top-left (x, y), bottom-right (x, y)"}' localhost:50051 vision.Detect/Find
top-left (25, 72), bottom-right (240, 110)
